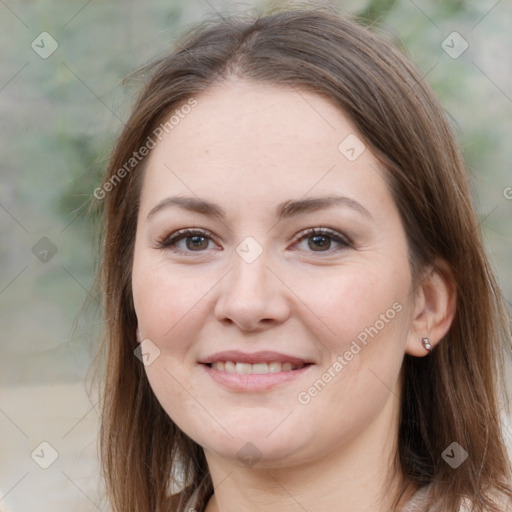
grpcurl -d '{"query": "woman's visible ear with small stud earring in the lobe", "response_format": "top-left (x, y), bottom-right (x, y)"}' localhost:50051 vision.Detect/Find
top-left (405, 260), bottom-right (457, 357)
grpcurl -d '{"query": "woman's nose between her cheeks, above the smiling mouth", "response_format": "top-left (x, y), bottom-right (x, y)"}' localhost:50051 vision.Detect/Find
top-left (215, 254), bottom-right (291, 331)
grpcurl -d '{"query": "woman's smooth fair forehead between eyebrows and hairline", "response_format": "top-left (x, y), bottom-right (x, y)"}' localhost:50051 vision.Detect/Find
top-left (141, 81), bottom-right (390, 214)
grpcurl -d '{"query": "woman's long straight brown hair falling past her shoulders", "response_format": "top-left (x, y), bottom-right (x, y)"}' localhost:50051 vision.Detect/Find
top-left (94, 7), bottom-right (512, 512)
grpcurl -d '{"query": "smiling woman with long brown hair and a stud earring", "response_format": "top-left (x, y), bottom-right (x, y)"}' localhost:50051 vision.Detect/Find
top-left (95, 8), bottom-right (512, 512)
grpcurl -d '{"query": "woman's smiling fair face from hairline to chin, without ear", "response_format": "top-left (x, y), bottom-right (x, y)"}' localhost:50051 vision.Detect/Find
top-left (132, 81), bottom-right (420, 466)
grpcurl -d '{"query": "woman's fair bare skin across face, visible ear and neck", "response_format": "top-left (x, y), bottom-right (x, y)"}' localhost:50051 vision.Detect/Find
top-left (132, 79), bottom-right (454, 512)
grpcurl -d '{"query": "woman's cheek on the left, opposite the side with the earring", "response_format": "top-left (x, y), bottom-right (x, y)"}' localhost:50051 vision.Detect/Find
top-left (132, 251), bottom-right (215, 433)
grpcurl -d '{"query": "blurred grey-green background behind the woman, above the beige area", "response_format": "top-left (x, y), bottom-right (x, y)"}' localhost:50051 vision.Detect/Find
top-left (0, 0), bottom-right (512, 385)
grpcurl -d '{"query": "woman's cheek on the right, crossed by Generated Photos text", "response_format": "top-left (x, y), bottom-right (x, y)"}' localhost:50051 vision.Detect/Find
top-left (296, 268), bottom-right (409, 448)
